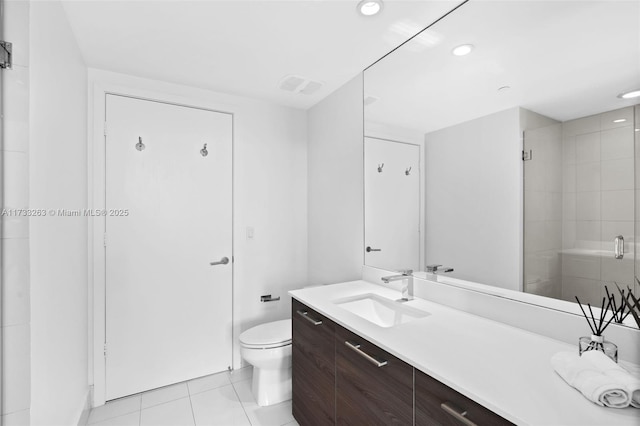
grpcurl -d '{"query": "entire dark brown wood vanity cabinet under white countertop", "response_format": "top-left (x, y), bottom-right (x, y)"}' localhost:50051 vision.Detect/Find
top-left (292, 299), bottom-right (511, 426)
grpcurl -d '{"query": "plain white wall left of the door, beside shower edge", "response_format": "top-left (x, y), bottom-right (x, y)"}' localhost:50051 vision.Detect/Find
top-left (29, 1), bottom-right (88, 425)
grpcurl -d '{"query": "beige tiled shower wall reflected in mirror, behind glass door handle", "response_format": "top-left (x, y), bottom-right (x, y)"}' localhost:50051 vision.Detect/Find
top-left (562, 107), bottom-right (635, 305)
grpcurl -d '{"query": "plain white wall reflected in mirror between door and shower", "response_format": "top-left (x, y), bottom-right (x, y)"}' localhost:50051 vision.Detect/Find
top-left (425, 108), bottom-right (522, 290)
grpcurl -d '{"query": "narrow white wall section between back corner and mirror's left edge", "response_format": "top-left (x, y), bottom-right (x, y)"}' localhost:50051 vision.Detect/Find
top-left (308, 75), bottom-right (364, 284)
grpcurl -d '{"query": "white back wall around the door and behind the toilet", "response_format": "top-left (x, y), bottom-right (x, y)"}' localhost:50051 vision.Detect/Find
top-left (89, 69), bottom-right (307, 401)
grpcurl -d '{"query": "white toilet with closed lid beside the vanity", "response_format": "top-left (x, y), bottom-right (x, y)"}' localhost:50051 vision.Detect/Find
top-left (240, 319), bottom-right (291, 406)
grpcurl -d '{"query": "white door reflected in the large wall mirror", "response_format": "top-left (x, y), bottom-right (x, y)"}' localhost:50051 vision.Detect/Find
top-left (364, 137), bottom-right (421, 270)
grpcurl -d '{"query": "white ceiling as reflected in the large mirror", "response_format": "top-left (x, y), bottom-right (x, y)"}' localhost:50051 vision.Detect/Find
top-left (365, 0), bottom-right (640, 133)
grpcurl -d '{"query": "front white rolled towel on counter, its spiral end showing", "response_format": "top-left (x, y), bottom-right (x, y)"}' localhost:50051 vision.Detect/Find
top-left (551, 351), bottom-right (631, 408)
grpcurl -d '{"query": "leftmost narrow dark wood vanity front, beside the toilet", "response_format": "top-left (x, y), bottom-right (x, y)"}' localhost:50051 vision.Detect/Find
top-left (291, 299), bottom-right (336, 426)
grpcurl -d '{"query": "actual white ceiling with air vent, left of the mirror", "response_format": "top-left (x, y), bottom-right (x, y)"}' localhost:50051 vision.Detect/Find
top-left (64, 0), bottom-right (461, 109)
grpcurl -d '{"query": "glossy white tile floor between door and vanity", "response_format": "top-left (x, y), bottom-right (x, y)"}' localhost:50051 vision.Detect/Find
top-left (88, 367), bottom-right (298, 426)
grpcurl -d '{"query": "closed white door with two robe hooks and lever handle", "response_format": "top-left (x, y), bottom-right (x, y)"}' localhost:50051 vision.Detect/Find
top-left (105, 95), bottom-right (232, 400)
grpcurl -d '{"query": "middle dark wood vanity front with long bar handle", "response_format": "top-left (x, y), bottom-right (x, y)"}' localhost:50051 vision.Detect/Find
top-left (336, 326), bottom-right (413, 426)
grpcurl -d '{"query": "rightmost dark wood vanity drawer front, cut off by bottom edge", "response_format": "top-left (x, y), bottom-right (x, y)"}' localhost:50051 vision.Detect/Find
top-left (415, 370), bottom-right (512, 426)
